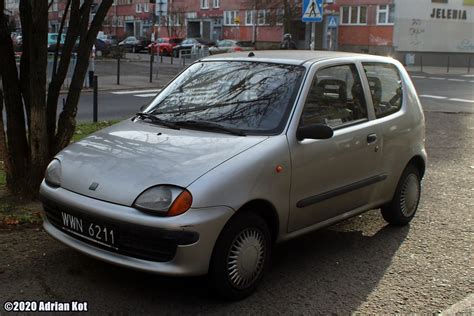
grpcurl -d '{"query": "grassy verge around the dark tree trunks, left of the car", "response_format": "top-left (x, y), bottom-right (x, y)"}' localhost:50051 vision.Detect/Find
top-left (0, 120), bottom-right (118, 228)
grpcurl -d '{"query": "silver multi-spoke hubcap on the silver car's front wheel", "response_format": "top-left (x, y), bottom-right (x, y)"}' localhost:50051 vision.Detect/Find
top-left (227, 228), bottom-right (265, 289)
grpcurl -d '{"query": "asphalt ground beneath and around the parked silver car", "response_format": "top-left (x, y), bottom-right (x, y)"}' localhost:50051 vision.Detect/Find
top-left (0, 112), bottom-right (474, 315)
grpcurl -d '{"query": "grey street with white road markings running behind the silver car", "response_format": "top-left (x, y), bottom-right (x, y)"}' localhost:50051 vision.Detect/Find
top-left (71, 73), bottom-right (474, 121)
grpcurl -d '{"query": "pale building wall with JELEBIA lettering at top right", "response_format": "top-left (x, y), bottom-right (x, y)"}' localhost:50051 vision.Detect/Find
top-left (393, 0), bottom-right (474, 67)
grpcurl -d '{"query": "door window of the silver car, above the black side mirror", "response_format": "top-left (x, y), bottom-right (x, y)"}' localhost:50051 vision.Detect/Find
top-left (300, 64), bottom-right (368, 128)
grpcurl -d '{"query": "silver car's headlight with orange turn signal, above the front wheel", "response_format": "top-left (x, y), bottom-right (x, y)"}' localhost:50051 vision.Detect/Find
top-left (133, 185), bottom-right (193, 216)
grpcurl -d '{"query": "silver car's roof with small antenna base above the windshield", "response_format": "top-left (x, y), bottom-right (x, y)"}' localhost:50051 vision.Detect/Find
top-left (203, 50), bottom-right (392, 65)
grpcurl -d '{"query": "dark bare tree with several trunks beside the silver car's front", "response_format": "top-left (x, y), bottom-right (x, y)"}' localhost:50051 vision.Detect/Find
top-left (0, 0), bottom-right (113, 196)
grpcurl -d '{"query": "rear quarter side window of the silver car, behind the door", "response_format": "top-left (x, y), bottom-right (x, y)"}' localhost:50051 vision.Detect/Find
top-left (363, 63), bottom-right (403, 118)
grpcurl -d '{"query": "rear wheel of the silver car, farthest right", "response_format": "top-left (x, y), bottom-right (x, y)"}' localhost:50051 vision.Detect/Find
top-left (381, 164), bottom-right (421, 226)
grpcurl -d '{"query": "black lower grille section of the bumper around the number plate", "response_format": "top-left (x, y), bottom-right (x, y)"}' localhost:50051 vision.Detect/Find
top-left (43, 199), bottom-right (199, 262)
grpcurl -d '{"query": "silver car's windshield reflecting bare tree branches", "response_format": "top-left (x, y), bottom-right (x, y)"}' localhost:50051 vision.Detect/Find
top-left (145, 61), bottom-right (305, 135)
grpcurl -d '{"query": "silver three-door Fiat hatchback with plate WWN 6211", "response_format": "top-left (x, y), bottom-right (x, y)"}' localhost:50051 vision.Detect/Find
top-left (40, 51), bottom-right (426, 300)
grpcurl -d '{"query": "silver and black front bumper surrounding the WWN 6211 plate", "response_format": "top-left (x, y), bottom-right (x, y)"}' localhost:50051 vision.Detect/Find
top-left (40, 182), bottom-right (234, 276)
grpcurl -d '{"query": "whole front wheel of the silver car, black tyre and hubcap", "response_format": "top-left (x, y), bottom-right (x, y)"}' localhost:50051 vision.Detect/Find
top-left (209, 212), bottom-right (272, 301)
